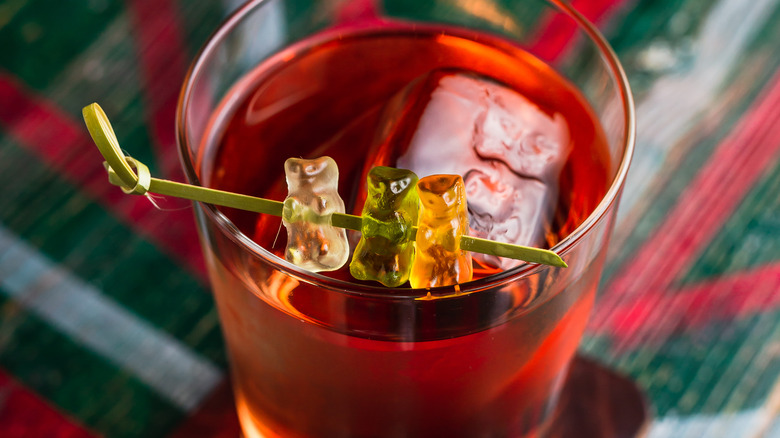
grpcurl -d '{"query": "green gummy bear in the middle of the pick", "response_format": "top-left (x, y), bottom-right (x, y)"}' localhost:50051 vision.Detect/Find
top-left (349, 166), bottom-right (419, 287)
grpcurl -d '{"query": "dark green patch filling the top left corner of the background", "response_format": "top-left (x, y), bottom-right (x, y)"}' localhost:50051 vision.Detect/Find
top-left (0, 0), bottom-right (122, 89)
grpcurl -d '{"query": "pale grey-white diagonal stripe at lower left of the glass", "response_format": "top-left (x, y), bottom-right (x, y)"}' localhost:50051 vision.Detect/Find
top-left (0, 226), bottom-right (223, 412)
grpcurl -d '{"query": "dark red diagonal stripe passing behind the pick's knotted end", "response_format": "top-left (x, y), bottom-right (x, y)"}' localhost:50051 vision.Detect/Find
top-left (0, 71), bottom-right (206, 278)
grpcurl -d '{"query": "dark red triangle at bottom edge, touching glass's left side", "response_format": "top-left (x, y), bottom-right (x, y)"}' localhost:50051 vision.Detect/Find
top-left (170, 382), bottom-right (241, 438)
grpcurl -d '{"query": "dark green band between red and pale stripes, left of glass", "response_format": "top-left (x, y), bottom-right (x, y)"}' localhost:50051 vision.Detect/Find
top-left (0, 141), bottom-right (226, 367)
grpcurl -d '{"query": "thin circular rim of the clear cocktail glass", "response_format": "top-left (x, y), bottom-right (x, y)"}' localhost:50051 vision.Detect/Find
top-left (176, 0), bottom-right (636, 300)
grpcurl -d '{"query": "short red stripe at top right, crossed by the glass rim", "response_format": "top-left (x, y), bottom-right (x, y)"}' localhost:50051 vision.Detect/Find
top-left (530, 0), bottom-right (625, 64)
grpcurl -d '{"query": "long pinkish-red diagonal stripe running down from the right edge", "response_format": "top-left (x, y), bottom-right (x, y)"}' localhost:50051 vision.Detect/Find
top-left (591, 74), bottom-right (780, 336)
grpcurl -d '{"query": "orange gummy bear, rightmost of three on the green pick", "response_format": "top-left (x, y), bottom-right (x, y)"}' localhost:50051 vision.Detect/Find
top-left (409, 175), bottom-right (473, 288)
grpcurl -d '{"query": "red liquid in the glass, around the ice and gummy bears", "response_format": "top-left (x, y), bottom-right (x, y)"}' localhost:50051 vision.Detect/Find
top-left (201, 29), bottom-right (611, 437)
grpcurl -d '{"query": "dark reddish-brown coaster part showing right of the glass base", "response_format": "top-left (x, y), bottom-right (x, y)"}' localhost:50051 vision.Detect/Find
top-left (546, 356), bottom-right (650, 438)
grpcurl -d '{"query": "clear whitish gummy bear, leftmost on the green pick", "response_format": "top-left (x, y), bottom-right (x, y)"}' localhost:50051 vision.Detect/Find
top-left (282, 157), bottom-right (349, 272)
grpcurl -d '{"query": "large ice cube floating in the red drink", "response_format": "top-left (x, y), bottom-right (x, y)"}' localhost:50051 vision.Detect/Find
top-left (371, 71), bottom-right (570, 269)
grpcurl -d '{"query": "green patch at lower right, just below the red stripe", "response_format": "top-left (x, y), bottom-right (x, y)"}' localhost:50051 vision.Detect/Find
top-left (613, 311), bottom-right (780, 417)
